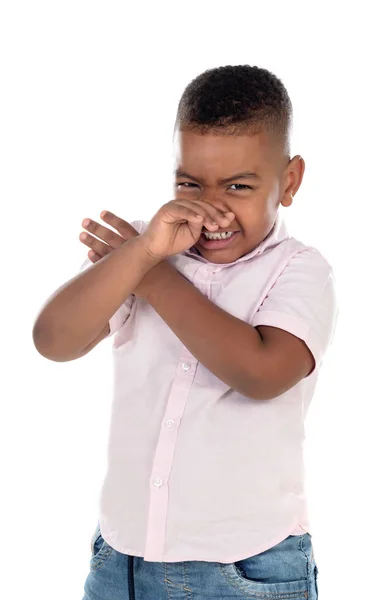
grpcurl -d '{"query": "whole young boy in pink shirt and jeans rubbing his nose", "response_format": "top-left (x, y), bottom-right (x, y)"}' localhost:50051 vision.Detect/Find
top-left (33, 65), bottom-right (338, 600)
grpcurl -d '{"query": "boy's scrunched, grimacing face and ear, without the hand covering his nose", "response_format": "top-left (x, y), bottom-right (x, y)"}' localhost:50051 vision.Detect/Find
top-left (173, 130), bottom-right (304, 264)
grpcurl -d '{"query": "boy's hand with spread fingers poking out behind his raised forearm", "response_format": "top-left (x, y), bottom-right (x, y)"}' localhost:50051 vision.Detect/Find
top-left (79, 210), bottom-right (162, 298)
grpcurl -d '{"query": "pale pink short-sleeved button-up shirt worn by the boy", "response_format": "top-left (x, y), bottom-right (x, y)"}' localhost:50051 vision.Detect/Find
top-left (82, 213), bottom-right (338, 563)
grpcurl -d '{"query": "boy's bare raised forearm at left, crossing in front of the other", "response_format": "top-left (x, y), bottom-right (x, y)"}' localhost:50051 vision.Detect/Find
top-left (33, 237), bottom-right (157, 359)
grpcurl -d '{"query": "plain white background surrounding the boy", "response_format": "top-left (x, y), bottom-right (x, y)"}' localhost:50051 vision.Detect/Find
top-left (0, 0), bottom-right (378, 600)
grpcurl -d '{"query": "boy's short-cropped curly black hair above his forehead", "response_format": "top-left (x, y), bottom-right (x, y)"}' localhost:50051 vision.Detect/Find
top-left (174, 65), bottom-right (293, 157)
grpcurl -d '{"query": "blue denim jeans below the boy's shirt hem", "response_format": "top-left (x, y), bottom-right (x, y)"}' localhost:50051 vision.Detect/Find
top-left (83, 525), bottom-right (318, 600)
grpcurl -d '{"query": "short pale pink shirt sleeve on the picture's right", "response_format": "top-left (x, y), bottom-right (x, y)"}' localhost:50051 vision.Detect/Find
top-left (251, 247), bottom-right (339, 372)
